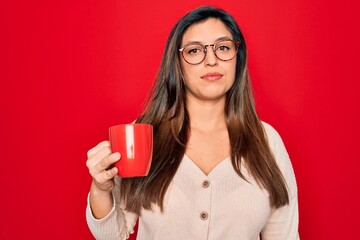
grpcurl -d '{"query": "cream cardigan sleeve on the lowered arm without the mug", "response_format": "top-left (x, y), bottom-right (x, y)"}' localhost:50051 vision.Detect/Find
top-left (261, 124), bottom-right (300, 240)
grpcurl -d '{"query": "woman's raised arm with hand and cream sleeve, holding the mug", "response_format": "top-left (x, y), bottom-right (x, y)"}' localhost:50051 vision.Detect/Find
top-left (86, 141), bottom-right (138, 240)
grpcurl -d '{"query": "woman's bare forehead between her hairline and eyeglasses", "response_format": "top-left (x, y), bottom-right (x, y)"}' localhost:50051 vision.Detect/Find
top-left (182, 18), bottom-right (232, 44)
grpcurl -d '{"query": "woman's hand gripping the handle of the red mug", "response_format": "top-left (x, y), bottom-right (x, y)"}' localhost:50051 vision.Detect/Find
top-left (86, 141), bottom-right (121, 192)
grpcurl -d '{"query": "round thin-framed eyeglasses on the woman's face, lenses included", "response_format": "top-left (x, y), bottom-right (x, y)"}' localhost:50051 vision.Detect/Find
top-left (179, 39), bottom-right (240, 65)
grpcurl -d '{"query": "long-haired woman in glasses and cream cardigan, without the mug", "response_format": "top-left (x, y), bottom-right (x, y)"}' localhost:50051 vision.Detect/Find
top-left (87, 7), bottom-right (299, 240)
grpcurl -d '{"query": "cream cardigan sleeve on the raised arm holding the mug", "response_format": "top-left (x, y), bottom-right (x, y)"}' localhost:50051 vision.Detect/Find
top-left (86, 177), bottom-right (138, 240)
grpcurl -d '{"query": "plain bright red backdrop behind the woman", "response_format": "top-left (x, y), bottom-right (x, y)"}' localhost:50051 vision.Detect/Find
top-left (0, 0), bottom-right (360, 239)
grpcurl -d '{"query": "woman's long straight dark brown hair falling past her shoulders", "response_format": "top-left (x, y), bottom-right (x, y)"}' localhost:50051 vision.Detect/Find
top-left (120, 7), bottom-right (289, 214)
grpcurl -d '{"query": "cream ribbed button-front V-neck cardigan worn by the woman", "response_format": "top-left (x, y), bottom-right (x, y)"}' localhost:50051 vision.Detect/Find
top-left (86, 123), bottom-right (299, 240)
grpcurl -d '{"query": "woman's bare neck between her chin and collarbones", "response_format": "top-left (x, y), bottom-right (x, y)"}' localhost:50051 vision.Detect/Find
top-left (187, 94), bottom-right (226, 131)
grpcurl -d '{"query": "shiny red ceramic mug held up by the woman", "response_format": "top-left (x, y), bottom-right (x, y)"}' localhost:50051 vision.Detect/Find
top-left (109, 123), bottom-right (153, 178)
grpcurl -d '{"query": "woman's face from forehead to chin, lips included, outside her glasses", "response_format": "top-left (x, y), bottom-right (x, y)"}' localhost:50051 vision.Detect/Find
top-left (181, 18), bottom-right (236, 101)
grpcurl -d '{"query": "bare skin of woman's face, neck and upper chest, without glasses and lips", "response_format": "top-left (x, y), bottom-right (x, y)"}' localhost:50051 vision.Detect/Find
top-left (181, 19), bottom-right (236, 174)
